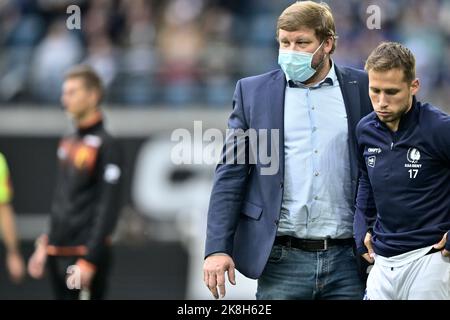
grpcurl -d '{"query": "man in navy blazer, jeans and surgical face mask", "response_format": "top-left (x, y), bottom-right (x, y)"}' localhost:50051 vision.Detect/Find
top-left (204, 1), bottom-right (372, 299)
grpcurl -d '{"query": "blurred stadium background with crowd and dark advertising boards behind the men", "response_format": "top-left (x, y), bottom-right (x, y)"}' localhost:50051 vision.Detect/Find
top-left (0, 0), bottom-right (450, 299)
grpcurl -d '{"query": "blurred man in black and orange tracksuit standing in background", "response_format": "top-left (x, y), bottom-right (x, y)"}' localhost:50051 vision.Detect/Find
top-left (28, 66), bottom-right (121, 299)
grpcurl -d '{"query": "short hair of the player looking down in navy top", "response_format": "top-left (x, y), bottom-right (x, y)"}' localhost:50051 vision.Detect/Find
top-left (364, 42), bottom-right (416, 83)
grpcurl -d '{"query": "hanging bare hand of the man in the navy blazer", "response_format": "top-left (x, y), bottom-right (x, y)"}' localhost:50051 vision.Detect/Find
top-left (203, 254), bottom-right (236, 299)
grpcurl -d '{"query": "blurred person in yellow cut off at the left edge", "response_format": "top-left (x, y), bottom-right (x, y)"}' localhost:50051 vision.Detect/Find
top-left (0, 153), bottom-right (25, 283)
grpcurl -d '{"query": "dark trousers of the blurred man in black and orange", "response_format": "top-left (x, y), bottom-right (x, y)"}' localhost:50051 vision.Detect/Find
top-left (47, 249), bottom-right (112, 300)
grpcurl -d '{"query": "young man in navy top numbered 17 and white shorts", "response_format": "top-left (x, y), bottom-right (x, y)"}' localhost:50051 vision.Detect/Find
top-left (354, 42), bottom-right (450, 300)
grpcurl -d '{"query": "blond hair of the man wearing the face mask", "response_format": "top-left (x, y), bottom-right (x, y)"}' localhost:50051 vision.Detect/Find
top-left (277, 1), bottom-right (337, 54)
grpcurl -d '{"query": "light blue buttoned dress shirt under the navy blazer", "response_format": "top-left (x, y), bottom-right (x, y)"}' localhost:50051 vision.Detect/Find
top-left (277, 64), bottom-right (353, 239)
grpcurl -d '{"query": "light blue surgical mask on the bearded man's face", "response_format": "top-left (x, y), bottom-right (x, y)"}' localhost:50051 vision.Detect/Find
top-left (278, 41), bottom-right (323, 82)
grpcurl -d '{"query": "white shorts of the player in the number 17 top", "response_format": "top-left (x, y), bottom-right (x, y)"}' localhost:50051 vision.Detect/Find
top-left (364, 246), bottom-right (450, 300)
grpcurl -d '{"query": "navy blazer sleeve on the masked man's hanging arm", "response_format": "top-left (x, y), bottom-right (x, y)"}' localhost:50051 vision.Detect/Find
top-left (205, 81), bottom-right (251, 257)
